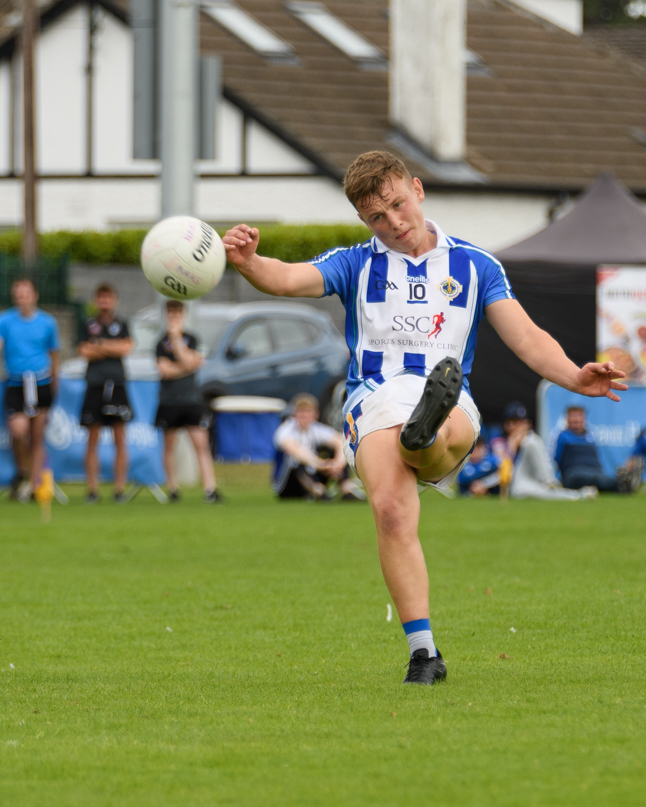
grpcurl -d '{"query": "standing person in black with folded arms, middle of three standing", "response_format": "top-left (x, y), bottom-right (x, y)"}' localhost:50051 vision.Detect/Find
top-left (78, 283), bottom-right (133, 504)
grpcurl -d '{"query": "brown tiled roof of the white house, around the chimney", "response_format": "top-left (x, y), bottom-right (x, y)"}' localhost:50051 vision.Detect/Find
top-left (0, 0), bottom-right (646, 194)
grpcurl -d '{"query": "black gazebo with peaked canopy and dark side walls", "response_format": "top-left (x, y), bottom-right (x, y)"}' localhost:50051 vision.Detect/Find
top-left (470, 173), bottom-right (646, 423)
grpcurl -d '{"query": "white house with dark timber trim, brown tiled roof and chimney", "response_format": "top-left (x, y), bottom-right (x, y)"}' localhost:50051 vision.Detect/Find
top-left (0, 0), bottom-right (646, 249)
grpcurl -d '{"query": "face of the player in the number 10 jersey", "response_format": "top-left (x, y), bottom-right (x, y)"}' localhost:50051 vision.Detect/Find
top-left (358, 177), bottom-right (435, 257)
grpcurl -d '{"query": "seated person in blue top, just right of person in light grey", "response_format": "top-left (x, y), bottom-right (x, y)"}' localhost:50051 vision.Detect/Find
top-left (554, 406), bottom-right (634, 493)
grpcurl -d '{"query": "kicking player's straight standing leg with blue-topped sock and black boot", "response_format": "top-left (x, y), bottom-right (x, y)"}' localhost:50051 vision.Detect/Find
top-left (356, 426), bottom-right (446, 684)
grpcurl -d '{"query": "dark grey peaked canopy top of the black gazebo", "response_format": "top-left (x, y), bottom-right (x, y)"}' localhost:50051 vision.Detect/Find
top-left (497, 171), bottom-right (646, 267)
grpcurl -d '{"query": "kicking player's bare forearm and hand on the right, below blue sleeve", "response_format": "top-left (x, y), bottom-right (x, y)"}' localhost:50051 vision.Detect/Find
top-left (485, 300), bottom-right (628, 401)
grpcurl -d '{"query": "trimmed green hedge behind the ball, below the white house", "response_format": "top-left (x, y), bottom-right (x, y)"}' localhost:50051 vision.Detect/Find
top-left (0, 224), bottom-right (370, 265)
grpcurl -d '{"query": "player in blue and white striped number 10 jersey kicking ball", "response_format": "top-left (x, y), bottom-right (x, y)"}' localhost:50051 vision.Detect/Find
top-left (223, 151), bottom-right (627, 685)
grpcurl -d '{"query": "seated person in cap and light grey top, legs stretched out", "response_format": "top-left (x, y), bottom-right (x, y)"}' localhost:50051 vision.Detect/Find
top-left (503, 401), bottom-right (599, 501)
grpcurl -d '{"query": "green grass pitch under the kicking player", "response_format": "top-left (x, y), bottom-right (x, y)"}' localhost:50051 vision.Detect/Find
top-left (0, 468), bottom-right (646, 807)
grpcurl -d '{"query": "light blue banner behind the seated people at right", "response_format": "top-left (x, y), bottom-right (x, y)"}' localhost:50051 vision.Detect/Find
top-left (537, 381), bottom-right (646, 474)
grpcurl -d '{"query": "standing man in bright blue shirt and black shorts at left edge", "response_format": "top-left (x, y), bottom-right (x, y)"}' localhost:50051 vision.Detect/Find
top-left (0, 278), bottom-right (60, 500)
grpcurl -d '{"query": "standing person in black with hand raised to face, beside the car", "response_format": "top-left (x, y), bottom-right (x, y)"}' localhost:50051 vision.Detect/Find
top-left (155, 300), bottom-right (222, 504)
